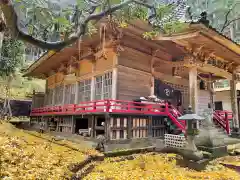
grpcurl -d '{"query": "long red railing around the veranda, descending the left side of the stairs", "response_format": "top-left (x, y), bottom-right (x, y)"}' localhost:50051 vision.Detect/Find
top-left (31, 100), bottom-right (185, 132)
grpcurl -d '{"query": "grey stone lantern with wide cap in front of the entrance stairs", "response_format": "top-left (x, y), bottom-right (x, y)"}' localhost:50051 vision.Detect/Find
top-left (178, 107), bottom-right (204, 160)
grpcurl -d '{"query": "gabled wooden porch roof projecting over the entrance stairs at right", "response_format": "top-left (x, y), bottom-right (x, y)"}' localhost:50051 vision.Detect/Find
top-left (156, 23), bottom-right (240, 72)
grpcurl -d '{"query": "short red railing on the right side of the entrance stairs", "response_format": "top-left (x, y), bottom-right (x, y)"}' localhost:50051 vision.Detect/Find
top-left (213, 110), bottom-right (233, 134)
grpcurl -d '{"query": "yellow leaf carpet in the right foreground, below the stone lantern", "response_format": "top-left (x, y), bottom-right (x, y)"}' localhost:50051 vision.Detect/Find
top-left (85, 154), bottom-right (240, 180)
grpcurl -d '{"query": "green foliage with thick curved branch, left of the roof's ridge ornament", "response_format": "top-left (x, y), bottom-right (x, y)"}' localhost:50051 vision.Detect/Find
top-left (0, 0), bottom-right (186, 49)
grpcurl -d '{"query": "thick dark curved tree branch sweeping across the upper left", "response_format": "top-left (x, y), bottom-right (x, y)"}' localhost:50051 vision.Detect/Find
top-left (0, 0), bottom-right (153, 50)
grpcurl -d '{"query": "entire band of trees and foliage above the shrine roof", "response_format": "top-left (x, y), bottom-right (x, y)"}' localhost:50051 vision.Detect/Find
top-left (0, 0), bottom-right (240, 50)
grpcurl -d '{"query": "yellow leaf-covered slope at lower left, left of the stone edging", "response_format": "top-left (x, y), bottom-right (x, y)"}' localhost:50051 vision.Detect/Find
top-left (0, 123), bottom-right (97, 180)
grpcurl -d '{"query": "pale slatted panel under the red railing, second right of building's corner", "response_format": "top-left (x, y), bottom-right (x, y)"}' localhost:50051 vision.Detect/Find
top-left (132, 118), bottom-right (148, 138)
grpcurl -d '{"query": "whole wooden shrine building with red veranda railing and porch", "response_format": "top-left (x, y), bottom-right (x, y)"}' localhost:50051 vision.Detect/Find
top-left (26, 21), bottom-right (240, 142)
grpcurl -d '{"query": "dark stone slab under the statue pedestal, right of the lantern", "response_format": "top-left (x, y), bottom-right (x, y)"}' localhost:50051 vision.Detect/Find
top-left (198, 145), bottom-right (228, 157)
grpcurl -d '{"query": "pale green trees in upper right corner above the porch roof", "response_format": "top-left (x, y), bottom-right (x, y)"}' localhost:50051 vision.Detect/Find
top-left (187, 0), bottom-right (240, 42)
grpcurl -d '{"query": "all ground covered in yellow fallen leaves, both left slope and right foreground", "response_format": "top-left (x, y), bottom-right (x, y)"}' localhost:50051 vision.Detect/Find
top-left (0, 123), bottom-right (240, 180)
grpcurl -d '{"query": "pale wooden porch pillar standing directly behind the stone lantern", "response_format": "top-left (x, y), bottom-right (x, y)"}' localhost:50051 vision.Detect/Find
top-left (189, 67), bottom-right (198, 113)
